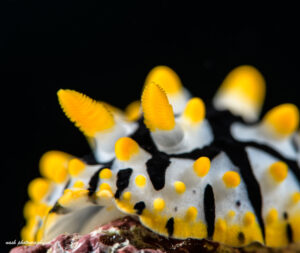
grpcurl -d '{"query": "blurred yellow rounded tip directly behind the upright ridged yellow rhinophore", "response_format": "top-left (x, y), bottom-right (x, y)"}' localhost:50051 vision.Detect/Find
top-left (145, 66), bottom-right (182, 94)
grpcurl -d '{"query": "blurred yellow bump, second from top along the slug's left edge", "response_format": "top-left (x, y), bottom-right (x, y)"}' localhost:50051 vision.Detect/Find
top-left (28, 178), bottom-right (50, 202)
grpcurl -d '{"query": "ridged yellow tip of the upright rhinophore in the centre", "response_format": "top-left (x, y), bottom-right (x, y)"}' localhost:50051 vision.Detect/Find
top-left (142, 83), bottom-right (175, 131)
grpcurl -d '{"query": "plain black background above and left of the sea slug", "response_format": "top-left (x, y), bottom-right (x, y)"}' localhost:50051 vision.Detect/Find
top-left (0, 0), bottom-right (300, 251)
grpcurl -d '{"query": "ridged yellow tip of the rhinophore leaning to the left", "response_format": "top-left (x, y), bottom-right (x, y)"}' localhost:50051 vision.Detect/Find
top-left (57, 89), bottom-right (115, 137)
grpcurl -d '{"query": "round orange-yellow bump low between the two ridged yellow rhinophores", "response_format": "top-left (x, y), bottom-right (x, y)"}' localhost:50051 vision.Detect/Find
top-left (115, 137), bottom-right (139, 161)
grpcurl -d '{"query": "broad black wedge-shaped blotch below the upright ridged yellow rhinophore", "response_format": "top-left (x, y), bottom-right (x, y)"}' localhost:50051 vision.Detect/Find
top-left (146, 152), bottom-right (170, 191)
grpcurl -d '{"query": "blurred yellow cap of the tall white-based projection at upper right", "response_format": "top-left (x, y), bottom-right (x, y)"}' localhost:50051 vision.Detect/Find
top-left (220, 65), bottom-right (266, 108)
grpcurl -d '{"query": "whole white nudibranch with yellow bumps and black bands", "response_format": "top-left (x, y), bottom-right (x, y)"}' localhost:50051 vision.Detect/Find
top-left (21, 65), bottom-right (300, 247)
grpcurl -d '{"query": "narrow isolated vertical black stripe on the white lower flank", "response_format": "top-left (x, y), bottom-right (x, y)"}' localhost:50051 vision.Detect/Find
top-left (203, 184), bottom-right (215, 239)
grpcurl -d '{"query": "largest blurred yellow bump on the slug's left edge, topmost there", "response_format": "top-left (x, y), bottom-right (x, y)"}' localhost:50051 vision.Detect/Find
top-left (39, 151), bottom-right (71, 183)
